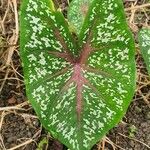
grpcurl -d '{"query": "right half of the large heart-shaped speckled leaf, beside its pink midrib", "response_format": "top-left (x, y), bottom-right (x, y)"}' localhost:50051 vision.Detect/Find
top-left (71, 0), bottom-right (136, 147)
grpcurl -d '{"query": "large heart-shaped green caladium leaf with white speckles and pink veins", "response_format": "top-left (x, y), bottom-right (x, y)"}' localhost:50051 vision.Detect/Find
top-left (20, 0), bottom-right (135, 150)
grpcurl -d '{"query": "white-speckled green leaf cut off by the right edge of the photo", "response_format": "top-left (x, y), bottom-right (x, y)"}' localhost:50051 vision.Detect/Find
top-left (139, 28), bottom-right (150, 74)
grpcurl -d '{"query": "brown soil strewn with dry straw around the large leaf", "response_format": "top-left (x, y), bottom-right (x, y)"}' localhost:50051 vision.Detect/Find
top-left (0, 0), bottom-right (150, 150)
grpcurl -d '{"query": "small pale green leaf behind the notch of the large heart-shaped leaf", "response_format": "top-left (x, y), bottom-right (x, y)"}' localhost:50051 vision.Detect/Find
top-left (67, 0), bottom-right (93, 34)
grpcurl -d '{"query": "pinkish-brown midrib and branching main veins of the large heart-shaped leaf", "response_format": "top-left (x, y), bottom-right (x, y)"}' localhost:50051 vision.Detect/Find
top-left (49, 30), bottom-right (93, 125)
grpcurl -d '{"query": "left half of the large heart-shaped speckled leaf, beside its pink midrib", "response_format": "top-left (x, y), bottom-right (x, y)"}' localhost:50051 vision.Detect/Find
top-left (20, 0), bottom-right (82, 149)
